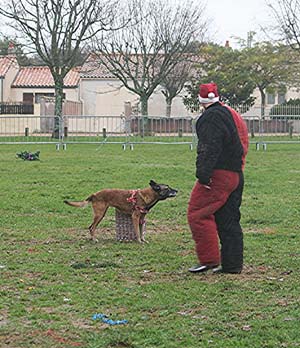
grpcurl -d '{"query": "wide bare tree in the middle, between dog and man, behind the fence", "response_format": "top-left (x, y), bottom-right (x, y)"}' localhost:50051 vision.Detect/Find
top-left (95, 0), bottom-right (205, 115)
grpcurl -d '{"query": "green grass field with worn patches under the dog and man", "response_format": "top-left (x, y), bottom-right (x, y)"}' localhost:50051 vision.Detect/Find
top-left (0, 144), bottom-right (300, 348)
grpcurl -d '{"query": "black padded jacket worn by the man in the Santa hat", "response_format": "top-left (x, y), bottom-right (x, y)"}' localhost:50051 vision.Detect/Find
top-left (196, 102), bottom-right (243, 185)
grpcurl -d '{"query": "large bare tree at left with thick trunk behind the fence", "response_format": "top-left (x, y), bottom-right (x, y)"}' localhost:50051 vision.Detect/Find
top-left (0, 0), bottom-right (117, 136)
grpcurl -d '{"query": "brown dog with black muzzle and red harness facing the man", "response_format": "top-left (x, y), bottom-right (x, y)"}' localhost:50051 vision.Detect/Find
top-left (64, 180), bottom-right (177, 243)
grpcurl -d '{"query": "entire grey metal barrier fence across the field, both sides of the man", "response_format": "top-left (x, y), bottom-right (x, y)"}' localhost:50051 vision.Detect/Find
top-left (0, 115), bottom-right (300, 149)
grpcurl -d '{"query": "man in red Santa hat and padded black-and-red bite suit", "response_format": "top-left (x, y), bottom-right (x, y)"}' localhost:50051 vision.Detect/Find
top-left (187, 83), bottom-right (249, 273)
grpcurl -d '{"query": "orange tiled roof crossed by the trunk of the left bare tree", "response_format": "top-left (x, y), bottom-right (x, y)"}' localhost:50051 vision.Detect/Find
top-left (12, 66), bottom-right (80, 88)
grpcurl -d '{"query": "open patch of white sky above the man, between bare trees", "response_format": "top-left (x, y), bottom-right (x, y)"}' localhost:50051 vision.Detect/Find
top-left (206, 0), bottom-right (276, 47)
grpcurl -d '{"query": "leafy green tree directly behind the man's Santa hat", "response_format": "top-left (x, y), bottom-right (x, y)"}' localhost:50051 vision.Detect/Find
top-left (184, 44), bottom-right (255, 111)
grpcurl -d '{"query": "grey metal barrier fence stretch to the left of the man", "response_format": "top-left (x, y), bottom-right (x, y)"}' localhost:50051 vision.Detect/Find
top-left (0, 115), bottom-right (195, 149)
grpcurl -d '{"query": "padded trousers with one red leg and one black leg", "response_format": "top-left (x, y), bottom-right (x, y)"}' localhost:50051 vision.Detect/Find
top-left (187, 170), bottom-right (244, 272)
